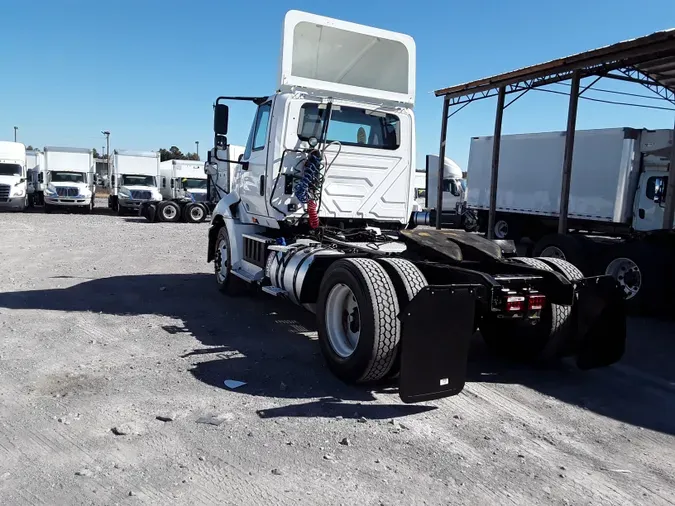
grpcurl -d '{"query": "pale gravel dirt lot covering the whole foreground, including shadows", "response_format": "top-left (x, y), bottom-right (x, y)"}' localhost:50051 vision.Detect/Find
top-left (0, 202), bottom-right (675, 505)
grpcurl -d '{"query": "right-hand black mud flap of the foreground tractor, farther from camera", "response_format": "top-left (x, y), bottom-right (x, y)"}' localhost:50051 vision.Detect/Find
top-left (576, 276), bottom-right (626, 370)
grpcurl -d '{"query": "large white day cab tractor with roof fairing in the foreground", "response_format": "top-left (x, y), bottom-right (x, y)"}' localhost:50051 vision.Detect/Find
top-left (207, 11), bottom-right (626, 402)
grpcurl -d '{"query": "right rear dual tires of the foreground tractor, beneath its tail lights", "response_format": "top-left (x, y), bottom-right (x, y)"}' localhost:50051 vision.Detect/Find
top-left (478, 257), bottom-right (572, 362)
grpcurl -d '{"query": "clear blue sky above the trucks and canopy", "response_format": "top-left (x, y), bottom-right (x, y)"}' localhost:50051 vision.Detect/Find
top-left (0, 0), bottom-right (675, 167)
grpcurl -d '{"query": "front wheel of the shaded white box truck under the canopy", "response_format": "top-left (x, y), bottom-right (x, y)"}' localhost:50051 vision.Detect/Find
top-left (602, 242), bottom-right (672, 313)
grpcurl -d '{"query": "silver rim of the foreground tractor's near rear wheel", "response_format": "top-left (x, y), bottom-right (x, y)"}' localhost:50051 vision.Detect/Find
top-left (326, 283), bottom-right (361, 358)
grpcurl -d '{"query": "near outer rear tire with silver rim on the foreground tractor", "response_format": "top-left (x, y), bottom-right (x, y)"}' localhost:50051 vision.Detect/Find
top-left (316, 258), bottom-right (401, 383)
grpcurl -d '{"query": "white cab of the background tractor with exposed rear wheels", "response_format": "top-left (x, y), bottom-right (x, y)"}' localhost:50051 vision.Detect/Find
top-left (159, 160), bottom-right (207, 202)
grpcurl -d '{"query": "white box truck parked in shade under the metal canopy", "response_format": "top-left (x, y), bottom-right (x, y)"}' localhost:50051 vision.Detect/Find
top-left (468, 128), bottom-right (675, 309)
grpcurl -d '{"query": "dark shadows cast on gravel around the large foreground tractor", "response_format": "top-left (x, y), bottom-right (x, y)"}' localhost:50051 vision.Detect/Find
top-left (0, 274), bottom-right (675, 434)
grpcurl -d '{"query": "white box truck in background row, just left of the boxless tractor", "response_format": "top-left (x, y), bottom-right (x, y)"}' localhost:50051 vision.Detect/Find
top-left (108, 149), bottom-right (162, 214)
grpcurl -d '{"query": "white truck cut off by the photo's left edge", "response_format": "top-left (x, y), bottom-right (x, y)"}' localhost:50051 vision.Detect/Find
top-left (0, 141), bottom-right (28, 211)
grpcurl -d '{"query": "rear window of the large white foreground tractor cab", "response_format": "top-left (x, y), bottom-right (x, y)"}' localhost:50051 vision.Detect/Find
top-left (298, 104), bottom-right (400, 149)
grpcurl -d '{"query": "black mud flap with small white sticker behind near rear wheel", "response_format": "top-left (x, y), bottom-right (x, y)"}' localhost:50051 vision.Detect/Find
top-left (399, 285), bottom-right (480, 403)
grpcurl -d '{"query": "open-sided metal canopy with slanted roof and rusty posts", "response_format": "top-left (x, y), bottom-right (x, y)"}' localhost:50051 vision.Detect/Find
top-left (434, 29), bottom-right (675, 238)
